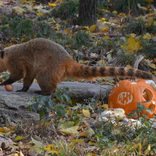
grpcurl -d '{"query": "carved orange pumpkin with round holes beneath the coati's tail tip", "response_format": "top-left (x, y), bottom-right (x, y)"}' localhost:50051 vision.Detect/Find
top-left (108, 79), bottom-right (156, 118)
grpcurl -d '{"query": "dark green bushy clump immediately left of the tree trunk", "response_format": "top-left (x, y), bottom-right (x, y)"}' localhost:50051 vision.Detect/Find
top-left (50, 0), bottom-right (78, 19)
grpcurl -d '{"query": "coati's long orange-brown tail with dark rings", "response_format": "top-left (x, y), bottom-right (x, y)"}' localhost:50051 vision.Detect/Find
top-left (67, 61), bottom-right (156, 81)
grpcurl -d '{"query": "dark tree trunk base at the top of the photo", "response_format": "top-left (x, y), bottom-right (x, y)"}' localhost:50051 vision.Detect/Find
top-left (78, 0), bottom-right (97, 26)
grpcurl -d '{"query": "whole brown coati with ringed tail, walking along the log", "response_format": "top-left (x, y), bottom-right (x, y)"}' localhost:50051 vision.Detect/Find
top-left (0, 38), bottom-right (156, 95)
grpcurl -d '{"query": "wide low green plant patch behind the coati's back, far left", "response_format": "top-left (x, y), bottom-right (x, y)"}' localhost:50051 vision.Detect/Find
top-left (0, 15), bottom-right (55, 40)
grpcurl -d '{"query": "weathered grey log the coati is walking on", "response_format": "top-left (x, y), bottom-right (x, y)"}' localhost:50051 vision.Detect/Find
top-left (0, 82), bottom-right (112, 122)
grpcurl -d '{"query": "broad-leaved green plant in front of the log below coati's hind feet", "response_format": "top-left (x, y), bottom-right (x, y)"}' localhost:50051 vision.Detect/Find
top-left (29, 87), bottom-right (72, 120)
